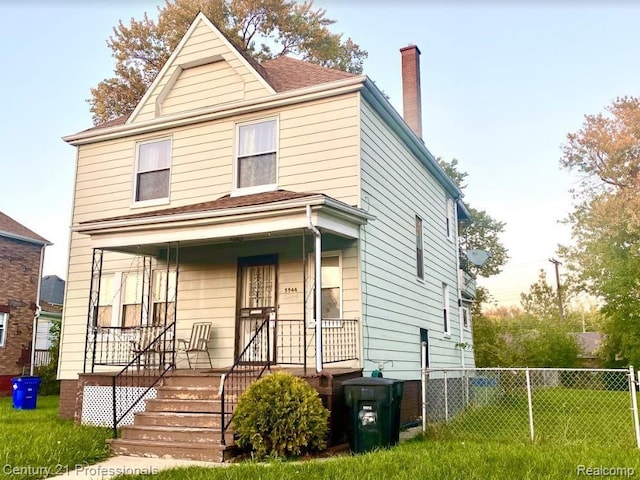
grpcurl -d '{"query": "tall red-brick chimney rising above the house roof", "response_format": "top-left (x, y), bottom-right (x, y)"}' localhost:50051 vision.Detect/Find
top-left (400, 45), bottom-right (422, 139)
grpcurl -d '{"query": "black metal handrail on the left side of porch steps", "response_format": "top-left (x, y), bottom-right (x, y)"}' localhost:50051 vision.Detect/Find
top-left (112, 322), bottom-right (176, 438)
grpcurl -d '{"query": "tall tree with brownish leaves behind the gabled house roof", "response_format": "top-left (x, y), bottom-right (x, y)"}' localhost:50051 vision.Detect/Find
top-left (89, 0), bottom-right (368, 124)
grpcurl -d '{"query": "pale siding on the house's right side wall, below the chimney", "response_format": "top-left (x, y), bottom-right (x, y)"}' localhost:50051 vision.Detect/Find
top-left (361, 99), bottom-right (460, 378)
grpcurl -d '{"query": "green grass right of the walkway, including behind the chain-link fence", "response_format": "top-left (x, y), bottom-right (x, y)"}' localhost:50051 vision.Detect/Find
top-left (110, 388), bottom-right (640, 480)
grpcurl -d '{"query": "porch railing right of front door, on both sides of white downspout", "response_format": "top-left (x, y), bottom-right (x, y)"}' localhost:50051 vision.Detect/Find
top-left (276, 318), bottom-right (358, 367)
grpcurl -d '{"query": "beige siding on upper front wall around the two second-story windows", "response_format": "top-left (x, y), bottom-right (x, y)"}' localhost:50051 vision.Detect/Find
top-left (74, 93), bottom-right (359, 224)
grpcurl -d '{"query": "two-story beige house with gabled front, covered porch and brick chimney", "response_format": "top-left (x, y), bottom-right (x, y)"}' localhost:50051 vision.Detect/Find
top-left (59, 14), bottom-right (473, 460)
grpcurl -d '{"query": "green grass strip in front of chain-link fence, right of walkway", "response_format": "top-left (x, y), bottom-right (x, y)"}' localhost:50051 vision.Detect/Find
top-left (112, 439), bottom-right (640, 480)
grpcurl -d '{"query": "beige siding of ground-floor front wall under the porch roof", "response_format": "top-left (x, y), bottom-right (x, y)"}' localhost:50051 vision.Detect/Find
top-left (60, 234), bottom-right (360, 379)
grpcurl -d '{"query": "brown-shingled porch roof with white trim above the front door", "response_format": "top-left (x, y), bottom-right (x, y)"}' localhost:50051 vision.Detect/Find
top-left (72, 190), bottom-right (374, 251)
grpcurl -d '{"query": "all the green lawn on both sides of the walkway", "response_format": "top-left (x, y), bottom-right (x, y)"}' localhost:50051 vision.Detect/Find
top-left (0, 390), bottom-right (640, 480)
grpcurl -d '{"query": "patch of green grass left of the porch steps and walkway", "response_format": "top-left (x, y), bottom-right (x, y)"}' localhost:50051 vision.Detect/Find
top-left (0, 396), bottom-right (111, 480)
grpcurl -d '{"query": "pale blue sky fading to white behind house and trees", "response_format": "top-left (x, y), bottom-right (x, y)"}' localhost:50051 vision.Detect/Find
top-left (0, 0), bottom-right (640, 305)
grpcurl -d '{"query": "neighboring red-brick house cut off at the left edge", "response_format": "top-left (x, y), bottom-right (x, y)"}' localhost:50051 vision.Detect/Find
top-left (0, 212), bottom-right (51, 395)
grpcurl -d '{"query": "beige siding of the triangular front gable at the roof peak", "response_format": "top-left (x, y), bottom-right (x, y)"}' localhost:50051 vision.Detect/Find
top-left (132, 21), bottom-right (269, 123)
